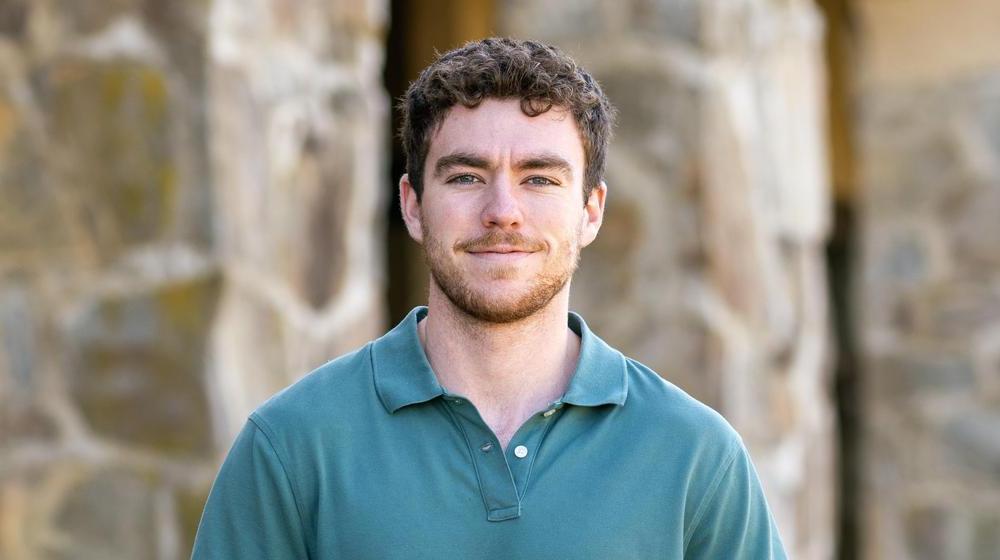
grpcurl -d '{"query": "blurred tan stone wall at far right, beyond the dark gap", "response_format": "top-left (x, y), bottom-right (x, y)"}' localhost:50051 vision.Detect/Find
top-left (856, 0), bottom-right (1000, 559)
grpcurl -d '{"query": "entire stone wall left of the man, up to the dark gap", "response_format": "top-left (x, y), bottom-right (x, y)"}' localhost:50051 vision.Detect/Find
top-left (0, 0), bottom-right (387, 560)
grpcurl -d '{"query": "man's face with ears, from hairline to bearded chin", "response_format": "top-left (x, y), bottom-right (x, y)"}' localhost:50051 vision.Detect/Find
top-left (400, 99), bottom-right (607, 323)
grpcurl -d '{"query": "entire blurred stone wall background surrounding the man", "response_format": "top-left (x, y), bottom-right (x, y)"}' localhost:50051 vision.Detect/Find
top-left (0, 0), bottom-right (1000, 560)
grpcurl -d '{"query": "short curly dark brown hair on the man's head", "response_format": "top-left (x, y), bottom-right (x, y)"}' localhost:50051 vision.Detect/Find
top-left (399, 37), bottom-right (615, 203)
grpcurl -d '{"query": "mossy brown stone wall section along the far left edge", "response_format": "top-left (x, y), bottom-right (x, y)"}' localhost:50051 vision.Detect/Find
top-left (0, 0), bottom-right (220, 560)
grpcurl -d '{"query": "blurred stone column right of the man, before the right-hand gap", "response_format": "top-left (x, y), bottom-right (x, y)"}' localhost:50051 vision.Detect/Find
top-left (498, 0), bottom-right (835, 559)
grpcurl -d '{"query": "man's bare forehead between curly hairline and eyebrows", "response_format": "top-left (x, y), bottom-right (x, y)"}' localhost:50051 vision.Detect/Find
top-left (427, 99), bottom-right (584, 167)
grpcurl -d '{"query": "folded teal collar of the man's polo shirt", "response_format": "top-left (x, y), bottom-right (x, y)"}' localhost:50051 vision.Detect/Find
top-left (372, 306), bottom-right (628, 414)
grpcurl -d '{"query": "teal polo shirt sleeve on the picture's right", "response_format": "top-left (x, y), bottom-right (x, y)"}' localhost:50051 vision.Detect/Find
top-left (684, 445), bottom-right (787, 560)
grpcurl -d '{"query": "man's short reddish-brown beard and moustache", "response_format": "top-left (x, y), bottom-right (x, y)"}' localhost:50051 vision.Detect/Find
top-left (423, 222), bottom-right (580, 323)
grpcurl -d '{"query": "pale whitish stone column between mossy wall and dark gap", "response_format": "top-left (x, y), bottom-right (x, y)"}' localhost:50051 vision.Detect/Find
top-left (209, 0), bottom-right (388, 441)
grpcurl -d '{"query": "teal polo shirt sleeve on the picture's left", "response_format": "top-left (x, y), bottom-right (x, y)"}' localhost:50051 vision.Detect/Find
top-left (191, 419), bottom-right (309, 560)
